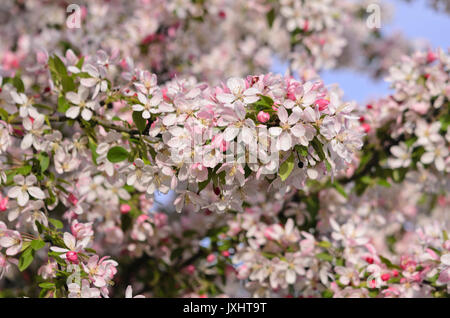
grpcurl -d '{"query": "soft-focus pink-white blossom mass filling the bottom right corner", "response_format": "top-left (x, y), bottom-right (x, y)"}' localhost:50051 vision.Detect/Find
top-left (227, 175), bottom-right (450, 297)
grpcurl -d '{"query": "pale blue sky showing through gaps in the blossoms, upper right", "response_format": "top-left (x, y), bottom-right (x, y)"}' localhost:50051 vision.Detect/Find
top-left (274, 0), bottom-right (450, 103)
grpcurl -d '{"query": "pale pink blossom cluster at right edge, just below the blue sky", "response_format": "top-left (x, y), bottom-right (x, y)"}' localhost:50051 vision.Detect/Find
top-left (361, 50), bottom-right (450, 174)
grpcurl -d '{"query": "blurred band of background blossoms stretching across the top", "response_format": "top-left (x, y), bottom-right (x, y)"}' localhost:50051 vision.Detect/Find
top-left (0, 0), bottom-right (413, 84)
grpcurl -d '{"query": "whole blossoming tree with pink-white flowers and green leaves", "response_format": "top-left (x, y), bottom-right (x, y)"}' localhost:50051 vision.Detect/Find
top-left (0, 0), bottom-right (450, 297)
